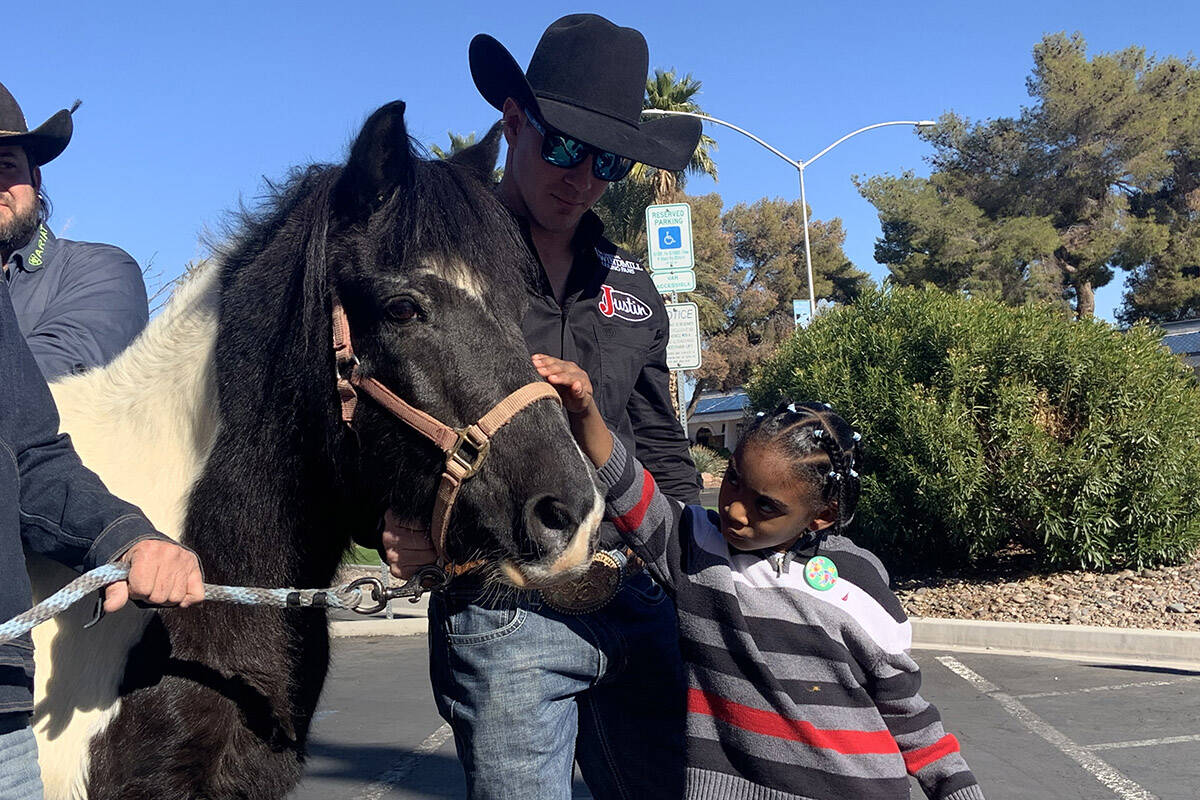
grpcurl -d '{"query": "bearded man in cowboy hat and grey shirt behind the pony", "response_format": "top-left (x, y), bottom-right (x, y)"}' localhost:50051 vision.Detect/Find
top-left (0, 84), bottom-right (149, 380)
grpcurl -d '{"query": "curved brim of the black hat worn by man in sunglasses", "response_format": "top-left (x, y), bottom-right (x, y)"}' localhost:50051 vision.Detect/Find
top-left (469, 34), bottom-right (701, 170)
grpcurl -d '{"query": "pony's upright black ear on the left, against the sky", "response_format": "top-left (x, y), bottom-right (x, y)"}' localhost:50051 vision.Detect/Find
top-left (334, 100), bottom-right (415, 218)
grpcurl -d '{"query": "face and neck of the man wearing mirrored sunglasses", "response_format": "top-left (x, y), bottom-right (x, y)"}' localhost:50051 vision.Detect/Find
top-left (504, 100), bottom-right (608, 233)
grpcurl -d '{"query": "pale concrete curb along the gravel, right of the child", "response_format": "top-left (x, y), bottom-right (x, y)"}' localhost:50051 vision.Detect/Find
top-left (912, 618), bottom-right (1200, 669)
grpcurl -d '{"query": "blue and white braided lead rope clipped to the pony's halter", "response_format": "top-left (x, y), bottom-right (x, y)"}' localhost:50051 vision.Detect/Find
top-left (0, 564), bottom-right (362, 644)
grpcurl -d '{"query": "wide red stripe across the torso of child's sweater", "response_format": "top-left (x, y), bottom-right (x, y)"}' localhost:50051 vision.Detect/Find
top-left (688, 688), bottom-right (899, 756)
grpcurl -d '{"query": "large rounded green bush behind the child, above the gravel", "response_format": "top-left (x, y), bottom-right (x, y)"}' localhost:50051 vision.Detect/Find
top-left (748, 288), bottom-right (1200, 570)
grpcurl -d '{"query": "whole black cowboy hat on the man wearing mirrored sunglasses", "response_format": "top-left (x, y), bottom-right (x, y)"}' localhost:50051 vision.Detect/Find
top-left (470, 14), bottom-right (701, 170)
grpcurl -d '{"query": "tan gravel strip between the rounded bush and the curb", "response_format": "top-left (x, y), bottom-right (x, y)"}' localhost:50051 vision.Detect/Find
top-left (893, 558), bottom-right (1200, 631)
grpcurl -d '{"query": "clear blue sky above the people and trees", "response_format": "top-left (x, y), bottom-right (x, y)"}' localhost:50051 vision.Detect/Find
top-left (11, 0), bottom-right (1200, 319)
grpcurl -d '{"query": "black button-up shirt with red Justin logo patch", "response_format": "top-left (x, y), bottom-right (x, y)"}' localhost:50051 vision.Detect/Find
top-left (522, 211), bottom-right (700, 537)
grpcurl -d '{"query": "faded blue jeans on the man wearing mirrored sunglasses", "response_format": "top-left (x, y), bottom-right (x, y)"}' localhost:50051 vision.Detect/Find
top-left (430, 572), bottom-right (684, 800)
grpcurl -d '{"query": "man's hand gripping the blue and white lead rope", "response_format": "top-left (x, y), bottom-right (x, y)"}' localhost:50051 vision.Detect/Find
top-left (104, 539), bottom-right (204, 613)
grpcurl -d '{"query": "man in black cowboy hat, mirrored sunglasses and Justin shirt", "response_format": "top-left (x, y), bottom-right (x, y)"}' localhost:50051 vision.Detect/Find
top-left (384, 14), bottom-right (700, 799)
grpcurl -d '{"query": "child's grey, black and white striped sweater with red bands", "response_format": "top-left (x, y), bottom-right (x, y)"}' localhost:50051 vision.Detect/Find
top-left (599, 438), bottom-right (983, 800)
